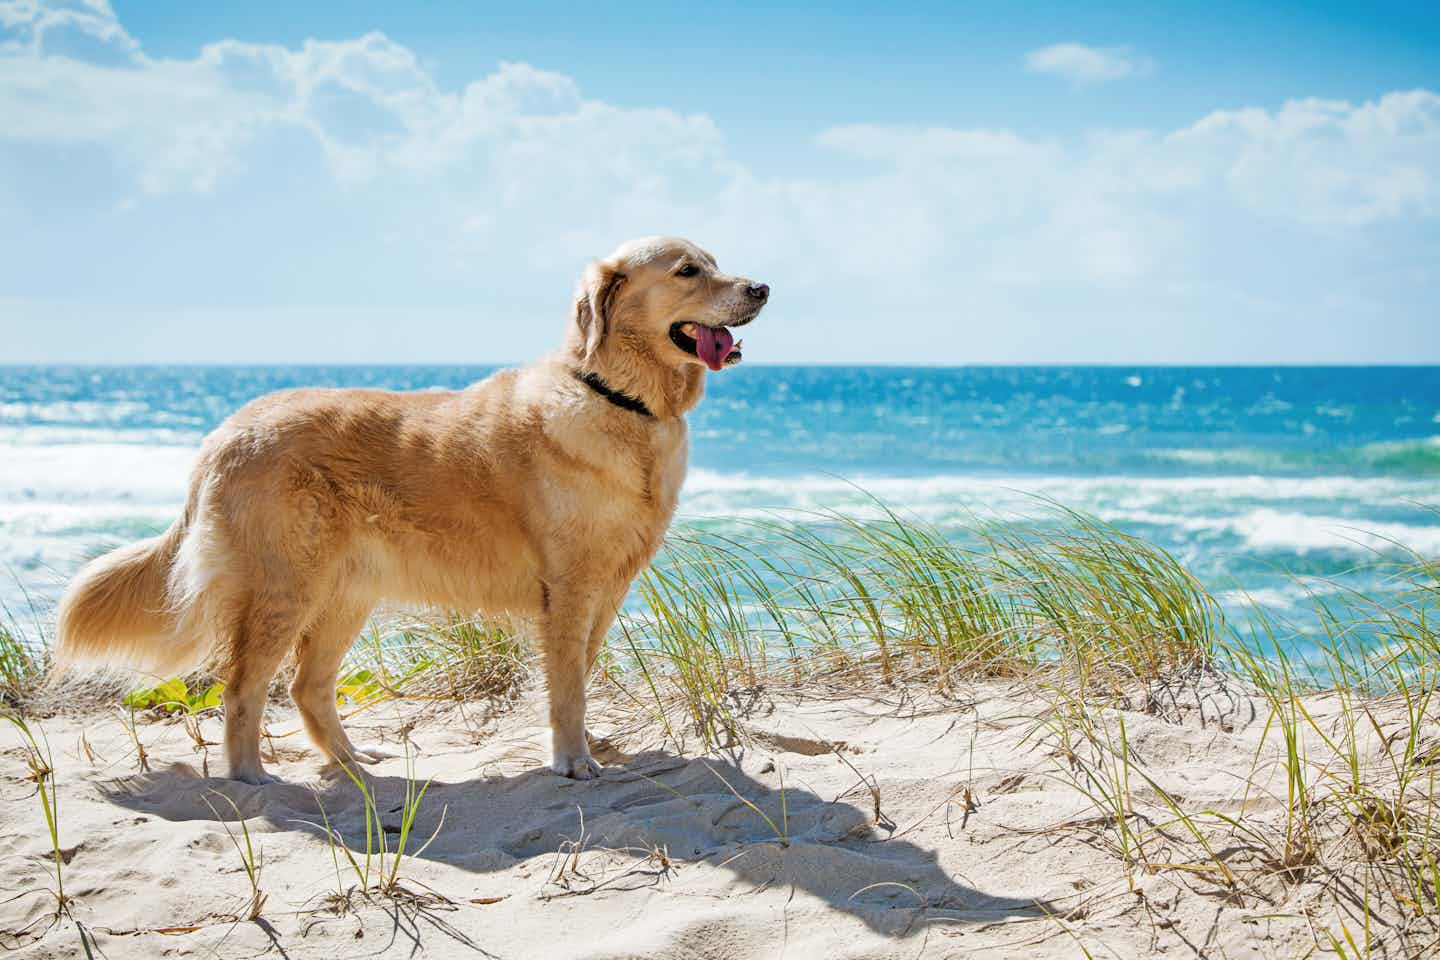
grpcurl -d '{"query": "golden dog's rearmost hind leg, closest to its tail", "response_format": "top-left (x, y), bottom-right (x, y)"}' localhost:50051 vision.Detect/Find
top-left (223, 590), bottom-right (305, 784)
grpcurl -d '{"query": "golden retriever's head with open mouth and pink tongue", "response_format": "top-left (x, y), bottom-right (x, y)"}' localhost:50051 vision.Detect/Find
top-left (575, 236), bottom-right (770, 370)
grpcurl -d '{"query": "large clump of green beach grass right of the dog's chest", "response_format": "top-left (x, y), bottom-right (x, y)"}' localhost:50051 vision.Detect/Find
top-left (611, 510), bottom-right (1225, 748)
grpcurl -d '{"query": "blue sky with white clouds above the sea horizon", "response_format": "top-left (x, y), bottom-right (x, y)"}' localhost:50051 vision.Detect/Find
top-left (0, 0), bottom-right (1440, 364)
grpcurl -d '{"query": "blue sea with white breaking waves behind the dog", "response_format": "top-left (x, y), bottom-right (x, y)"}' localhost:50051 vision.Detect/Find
top-left (0, 366), bottom-right (1440, 644)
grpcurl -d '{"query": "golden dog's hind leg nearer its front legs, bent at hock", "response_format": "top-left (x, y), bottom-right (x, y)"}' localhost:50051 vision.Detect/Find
top-left (289, 604), bottom-right (384, 763)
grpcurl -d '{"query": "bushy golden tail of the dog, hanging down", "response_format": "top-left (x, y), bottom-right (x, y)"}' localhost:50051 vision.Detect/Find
top-left (53, 511), bottom-right (202, 678)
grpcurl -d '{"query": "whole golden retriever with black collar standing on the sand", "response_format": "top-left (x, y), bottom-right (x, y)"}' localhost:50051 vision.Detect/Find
top-left (56, 237), bottom-right (770, 784)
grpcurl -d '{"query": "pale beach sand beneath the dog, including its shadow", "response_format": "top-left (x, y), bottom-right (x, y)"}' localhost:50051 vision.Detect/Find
top-left (0, 682), bottom-right (1422, 960)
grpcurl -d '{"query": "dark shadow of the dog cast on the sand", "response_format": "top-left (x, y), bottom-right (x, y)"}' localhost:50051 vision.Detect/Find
top-left (105, 751), bottom-right (1048, 937)
